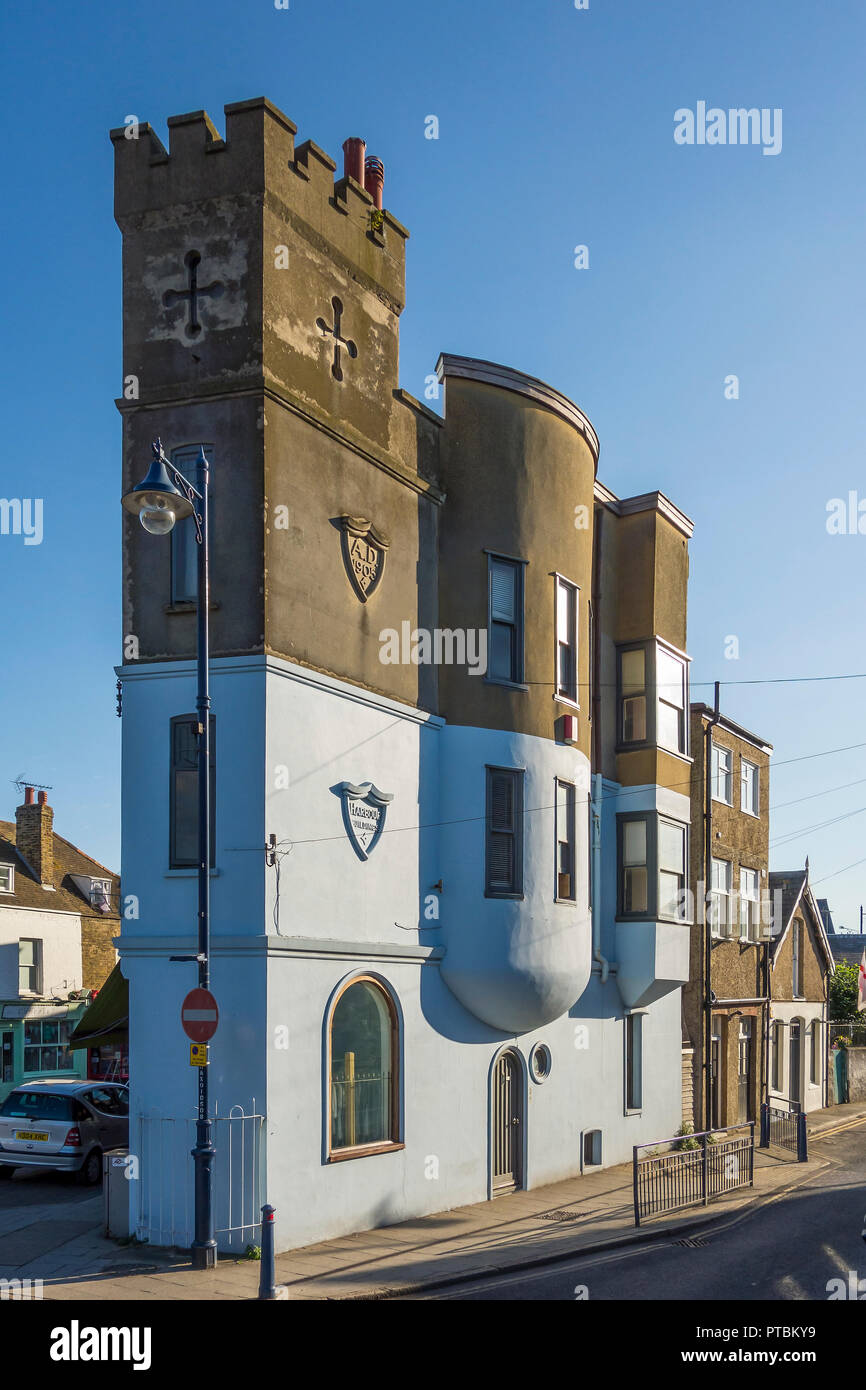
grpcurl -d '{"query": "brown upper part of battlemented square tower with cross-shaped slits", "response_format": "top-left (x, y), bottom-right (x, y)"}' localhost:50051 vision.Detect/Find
top-left (111, 99), bottom-right (441, 706)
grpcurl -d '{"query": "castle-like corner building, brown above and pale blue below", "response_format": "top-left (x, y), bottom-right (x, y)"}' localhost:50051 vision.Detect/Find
top-left (113, 100), bottom-right (692, 1248)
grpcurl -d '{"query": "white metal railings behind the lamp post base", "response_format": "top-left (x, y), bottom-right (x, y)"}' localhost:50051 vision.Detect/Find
top-left (135, 1101), bottom-right (264, 1252)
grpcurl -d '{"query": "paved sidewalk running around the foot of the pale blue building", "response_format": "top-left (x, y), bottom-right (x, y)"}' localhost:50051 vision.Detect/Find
top-left (6, 1102), bottom-right (866, 1302)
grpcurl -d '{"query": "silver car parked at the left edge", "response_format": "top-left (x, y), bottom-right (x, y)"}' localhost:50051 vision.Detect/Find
top-left (0, 1079), bottom-right (129, 1184)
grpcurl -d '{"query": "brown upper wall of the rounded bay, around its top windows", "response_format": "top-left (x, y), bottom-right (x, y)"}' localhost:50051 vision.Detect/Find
top-left (439, 377), bottom-right (595, 756)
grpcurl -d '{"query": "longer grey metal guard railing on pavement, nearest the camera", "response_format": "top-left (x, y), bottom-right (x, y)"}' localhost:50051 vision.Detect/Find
top-left (632, 1122), bottom-right (755, 1226)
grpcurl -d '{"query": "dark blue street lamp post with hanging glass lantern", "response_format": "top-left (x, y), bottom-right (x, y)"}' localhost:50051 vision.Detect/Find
top-left (121, 439), bottom-right (217, 1269)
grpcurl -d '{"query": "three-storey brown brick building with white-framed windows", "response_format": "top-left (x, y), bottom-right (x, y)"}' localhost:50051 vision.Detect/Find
top-left (683, 703), bottom-right (771, 1130)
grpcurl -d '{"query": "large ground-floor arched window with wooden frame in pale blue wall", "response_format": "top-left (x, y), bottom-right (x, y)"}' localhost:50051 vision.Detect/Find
top-left (328, 977), bottom-right (399, 1158)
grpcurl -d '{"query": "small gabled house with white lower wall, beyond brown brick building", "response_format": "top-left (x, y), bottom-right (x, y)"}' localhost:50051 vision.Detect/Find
top-left (769, 862), bottom-right (835, 1111)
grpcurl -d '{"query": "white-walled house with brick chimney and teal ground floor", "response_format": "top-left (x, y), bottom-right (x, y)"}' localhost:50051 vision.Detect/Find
top-left (0, 787), bottom-right (120, 1101)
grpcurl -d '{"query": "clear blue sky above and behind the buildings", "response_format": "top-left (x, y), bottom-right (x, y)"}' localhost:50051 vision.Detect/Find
top-left (0, 0), bottom-right (866, 927)
